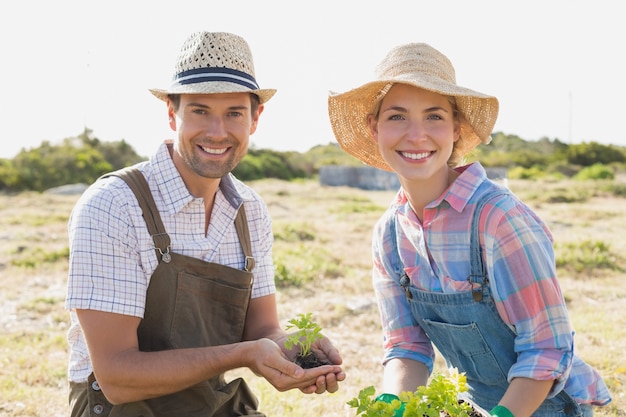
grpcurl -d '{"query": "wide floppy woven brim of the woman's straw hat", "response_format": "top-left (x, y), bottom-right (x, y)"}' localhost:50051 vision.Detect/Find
top-left (328, 78), bottom-right (499, 171)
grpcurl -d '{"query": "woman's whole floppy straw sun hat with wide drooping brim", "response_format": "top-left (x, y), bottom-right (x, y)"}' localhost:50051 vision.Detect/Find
top-left (328, 43), bottom-right (499, 171)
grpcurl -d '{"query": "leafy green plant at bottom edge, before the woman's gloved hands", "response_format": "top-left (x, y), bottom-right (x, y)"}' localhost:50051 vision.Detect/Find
top-left (347, 368), bottom-right (481, 417)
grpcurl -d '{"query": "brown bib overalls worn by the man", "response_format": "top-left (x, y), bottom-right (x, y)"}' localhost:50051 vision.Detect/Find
top-left (69, 168), bottom-right (264, 417)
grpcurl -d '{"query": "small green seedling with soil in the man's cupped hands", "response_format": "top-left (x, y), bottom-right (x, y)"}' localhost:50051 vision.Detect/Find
top-left (285, 313), bottom-right (323, 368)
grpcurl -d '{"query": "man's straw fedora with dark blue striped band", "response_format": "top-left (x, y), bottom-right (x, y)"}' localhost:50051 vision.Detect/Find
top-left (150, 32), bottom-right (276, 103)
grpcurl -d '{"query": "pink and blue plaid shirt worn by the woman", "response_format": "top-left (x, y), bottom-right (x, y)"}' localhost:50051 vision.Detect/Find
top-left (372, 163), bottom-right (610, 404)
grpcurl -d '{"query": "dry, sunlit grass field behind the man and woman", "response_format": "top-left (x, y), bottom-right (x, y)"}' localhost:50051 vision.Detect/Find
top-left (0, 180), bottom-right (626, 417)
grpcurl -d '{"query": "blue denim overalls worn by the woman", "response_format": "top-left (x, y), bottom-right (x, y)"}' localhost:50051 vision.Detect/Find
top-left (400, 190), bottom-right (593, 417)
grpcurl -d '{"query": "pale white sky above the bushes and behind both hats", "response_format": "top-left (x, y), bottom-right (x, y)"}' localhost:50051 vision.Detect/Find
top-left (0, 0), bottom-right (626, 158)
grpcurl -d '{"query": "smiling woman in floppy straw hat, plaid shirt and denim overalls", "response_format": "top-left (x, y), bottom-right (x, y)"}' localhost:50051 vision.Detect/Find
top-left (329, 43), bottom-right (611, 417)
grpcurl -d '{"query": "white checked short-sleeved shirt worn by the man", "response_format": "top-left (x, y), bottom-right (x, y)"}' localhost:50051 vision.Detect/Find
top-left (66, 143), bottom-right (275, 382)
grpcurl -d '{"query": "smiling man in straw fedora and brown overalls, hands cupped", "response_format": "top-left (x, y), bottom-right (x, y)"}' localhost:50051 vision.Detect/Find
top-left (66, 32), bottom-right (345, 416)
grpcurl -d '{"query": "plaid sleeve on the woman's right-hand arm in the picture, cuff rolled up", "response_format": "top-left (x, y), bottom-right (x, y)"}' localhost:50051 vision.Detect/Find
top-left (486, 205), bottom-right (574, 397)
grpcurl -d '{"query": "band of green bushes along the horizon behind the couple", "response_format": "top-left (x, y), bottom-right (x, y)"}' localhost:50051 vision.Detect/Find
top-left (0, 129), bottom-right (626, 192)
